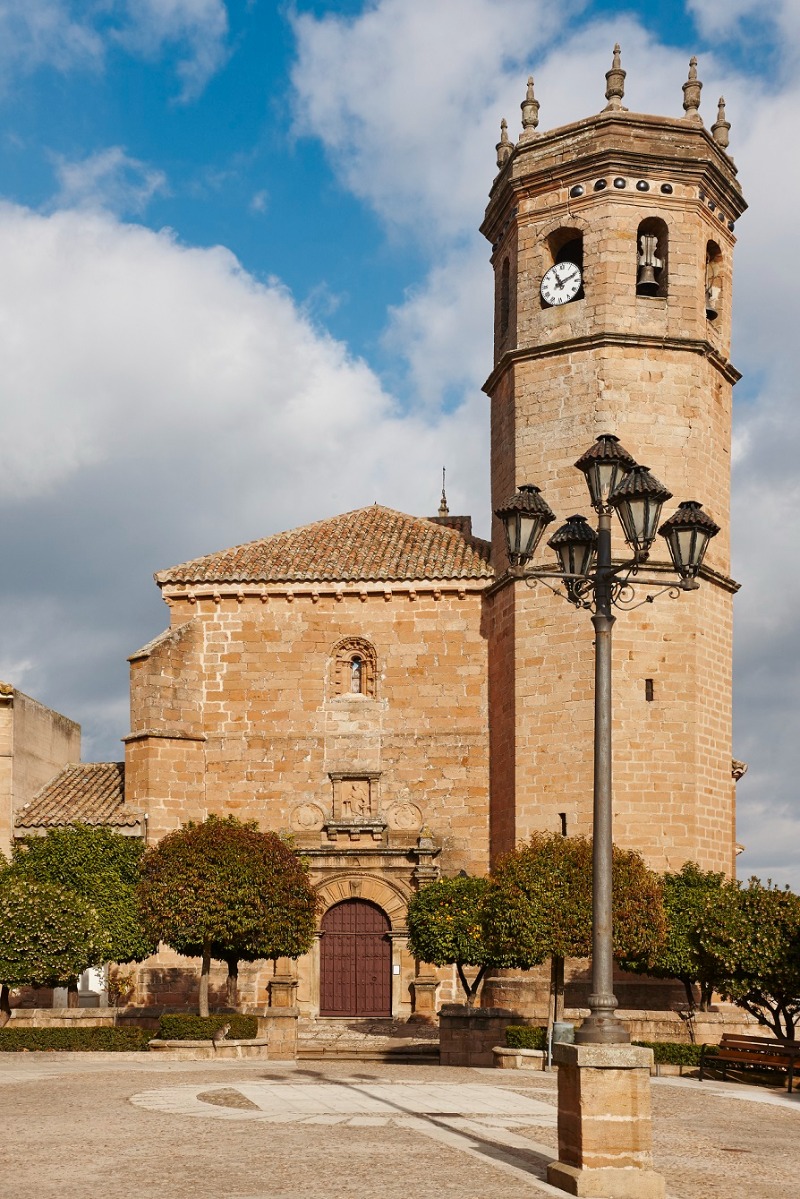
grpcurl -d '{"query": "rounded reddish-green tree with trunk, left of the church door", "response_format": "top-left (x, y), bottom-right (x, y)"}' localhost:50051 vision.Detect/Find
top-left (138, 815), bottom-right (318, 1016)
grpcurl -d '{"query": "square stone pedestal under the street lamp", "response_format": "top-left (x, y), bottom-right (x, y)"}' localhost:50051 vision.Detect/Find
top-left (547, 1044), bottom-right (664, 1199)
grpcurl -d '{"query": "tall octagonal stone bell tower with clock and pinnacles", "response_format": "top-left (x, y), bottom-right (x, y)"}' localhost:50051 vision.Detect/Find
top-left (481, 47), bottom-right (746, 873)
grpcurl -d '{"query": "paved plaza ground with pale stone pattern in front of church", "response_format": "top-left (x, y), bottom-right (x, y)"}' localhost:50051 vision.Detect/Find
top-left (0, 1054), bottom-right (800, 1199)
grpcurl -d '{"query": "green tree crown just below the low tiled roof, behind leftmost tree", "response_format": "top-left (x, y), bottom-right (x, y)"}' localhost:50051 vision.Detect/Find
top-left (11, 824), bottom-right (156, 962)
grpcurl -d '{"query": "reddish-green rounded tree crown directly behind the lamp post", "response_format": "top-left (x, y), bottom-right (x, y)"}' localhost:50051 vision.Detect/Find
top-left (483, 833), bottom-right (666, 970)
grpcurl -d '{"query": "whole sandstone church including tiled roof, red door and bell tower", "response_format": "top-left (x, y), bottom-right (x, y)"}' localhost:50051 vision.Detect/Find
top-left (18, 58), bottom-right (745, 1017)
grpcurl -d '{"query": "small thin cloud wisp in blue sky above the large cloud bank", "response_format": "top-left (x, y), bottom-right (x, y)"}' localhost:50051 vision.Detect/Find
top-left (53, 146), bottom-right (167, 216)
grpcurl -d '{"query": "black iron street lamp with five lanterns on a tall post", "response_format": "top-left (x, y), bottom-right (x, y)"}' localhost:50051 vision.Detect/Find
top-left (495, 433), bottom-right (720, 1044)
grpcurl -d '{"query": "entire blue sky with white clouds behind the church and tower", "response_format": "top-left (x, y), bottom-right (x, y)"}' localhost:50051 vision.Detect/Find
top-left (0, 0), bottom-right (800, 886)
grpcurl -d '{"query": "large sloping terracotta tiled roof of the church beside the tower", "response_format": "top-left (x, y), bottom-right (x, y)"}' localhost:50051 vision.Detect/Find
top-left (156, 504), bottom-right (493, 584)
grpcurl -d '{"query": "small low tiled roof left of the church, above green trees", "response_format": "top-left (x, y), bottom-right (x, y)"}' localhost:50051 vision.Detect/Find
top-left (14, 761), bottom-right (142, 832)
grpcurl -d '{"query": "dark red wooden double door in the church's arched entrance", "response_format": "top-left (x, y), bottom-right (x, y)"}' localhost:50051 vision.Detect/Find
top-left (319, 899), bottom-right (392, 1016)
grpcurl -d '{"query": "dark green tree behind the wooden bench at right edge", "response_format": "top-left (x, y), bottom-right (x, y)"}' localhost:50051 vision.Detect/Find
top-left (700, 879), bottom-right (800, 1041)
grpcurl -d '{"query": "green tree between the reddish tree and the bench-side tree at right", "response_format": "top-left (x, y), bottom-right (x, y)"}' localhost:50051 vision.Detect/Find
top-left (620, 862), bottom-right (735, 1011)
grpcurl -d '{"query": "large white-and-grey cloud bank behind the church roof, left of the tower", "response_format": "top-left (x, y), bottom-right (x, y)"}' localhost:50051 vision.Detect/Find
top-left (0, 197), bottom-right (488, 757)
